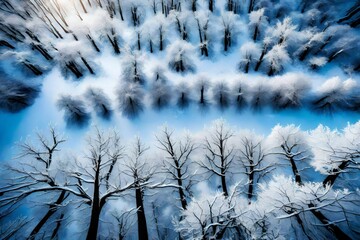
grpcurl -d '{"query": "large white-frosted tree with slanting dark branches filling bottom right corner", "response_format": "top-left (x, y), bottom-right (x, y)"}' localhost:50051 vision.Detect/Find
top-left (253, 175), bottom-right (358, 239)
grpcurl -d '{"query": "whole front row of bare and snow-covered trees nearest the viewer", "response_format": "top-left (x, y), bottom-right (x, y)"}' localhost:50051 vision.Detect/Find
top-left (0, 120), bottom-right (360, 239)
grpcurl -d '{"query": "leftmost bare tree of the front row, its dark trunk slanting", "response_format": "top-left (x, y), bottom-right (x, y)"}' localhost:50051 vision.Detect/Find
top-left (0, 127), bottom-right (69, 239)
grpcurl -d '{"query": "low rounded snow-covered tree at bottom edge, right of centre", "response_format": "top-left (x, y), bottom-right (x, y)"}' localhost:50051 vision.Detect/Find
top-left (175, 186), bottom-right (247, 239)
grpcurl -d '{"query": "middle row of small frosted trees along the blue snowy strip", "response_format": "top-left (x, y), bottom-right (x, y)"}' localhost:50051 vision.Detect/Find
top-left (58, 74), bottom-right (360, 125)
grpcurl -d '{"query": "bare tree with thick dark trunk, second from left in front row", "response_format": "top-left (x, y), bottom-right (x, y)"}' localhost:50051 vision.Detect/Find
top-left (67, 128), bottom-right (134, 239)
